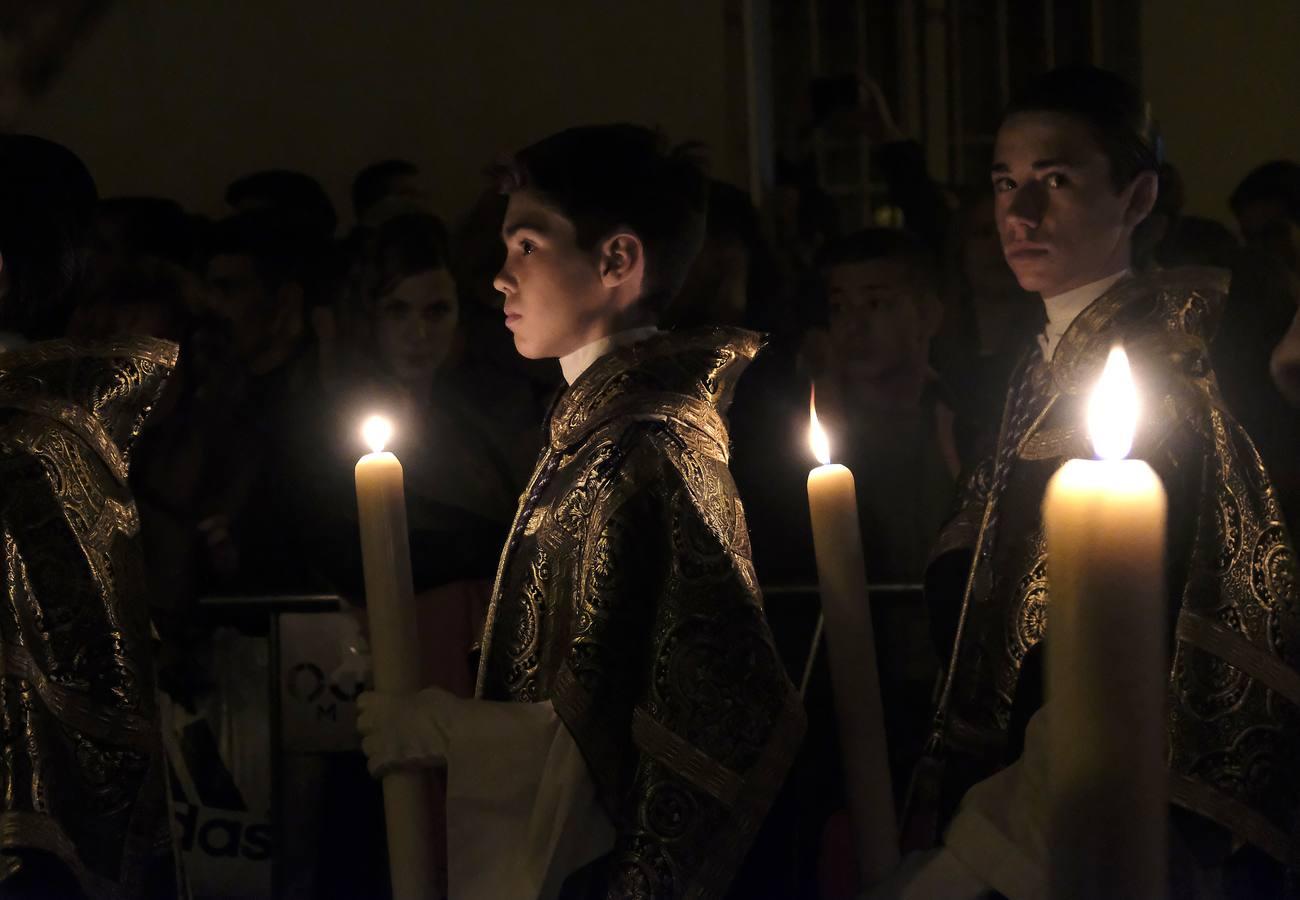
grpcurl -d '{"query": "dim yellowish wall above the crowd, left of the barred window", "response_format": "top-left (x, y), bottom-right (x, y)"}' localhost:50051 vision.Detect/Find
top-left (17, 0), bottom-right (744, 224)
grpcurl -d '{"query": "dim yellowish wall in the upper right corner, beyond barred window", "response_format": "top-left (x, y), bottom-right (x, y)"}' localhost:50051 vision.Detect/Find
top-left (1141, 0), bottom-right (1300, 226)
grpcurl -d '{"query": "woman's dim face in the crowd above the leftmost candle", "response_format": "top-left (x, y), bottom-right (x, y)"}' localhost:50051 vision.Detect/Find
top-left (374, 269), bottom-right (460, 382)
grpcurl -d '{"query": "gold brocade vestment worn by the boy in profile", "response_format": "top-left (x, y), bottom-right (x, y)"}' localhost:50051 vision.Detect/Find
top-left (478, 328), bottom-right (803, 897)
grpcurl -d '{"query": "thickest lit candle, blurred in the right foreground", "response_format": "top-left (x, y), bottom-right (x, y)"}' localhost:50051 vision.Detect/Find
top-left (1043, 347), bottom-right (1169, 899)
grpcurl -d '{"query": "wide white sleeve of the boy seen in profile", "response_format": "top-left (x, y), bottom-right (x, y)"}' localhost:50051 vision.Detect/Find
top-left (447, 700), bottom-right (614, 900)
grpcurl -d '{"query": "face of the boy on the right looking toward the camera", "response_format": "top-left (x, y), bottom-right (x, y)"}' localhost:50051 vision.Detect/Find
top-left (993, 112), bottom-right (1156, 297)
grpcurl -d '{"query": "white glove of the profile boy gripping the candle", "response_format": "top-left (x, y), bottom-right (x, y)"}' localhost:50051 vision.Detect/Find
top-left (356, 688), bottom-right (460, 778)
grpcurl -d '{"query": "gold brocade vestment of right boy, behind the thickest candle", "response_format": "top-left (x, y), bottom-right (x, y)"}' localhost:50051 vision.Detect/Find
top-left (931, 269), bottom-right (1300, 866)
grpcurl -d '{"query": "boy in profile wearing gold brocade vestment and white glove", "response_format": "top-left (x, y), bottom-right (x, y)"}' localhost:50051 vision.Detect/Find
top-left (359, 125), bottom-right (803, 897)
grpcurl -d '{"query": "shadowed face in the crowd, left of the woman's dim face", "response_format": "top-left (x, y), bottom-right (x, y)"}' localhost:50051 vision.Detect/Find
top-left (208, 254), bottom-right (303, 360)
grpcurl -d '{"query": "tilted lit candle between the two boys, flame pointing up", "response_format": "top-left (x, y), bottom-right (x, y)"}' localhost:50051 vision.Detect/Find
top-left (809, 398), bottom-right (898, 887)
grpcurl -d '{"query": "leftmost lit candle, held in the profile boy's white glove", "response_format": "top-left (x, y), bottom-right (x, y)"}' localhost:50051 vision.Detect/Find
top-left (356, 416), bottom-right (438, 900)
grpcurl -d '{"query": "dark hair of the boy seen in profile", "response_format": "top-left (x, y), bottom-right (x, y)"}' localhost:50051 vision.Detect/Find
top-left (493, 124), bottom-right (709, 312)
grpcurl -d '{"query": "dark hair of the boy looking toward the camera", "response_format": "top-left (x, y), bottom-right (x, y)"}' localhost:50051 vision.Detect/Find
top-left (1002, 65), bottom-right (1164, 191)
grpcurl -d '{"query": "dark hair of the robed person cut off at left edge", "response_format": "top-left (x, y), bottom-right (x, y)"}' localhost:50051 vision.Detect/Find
top-left (0, 134), bottom-right (96, 339)
